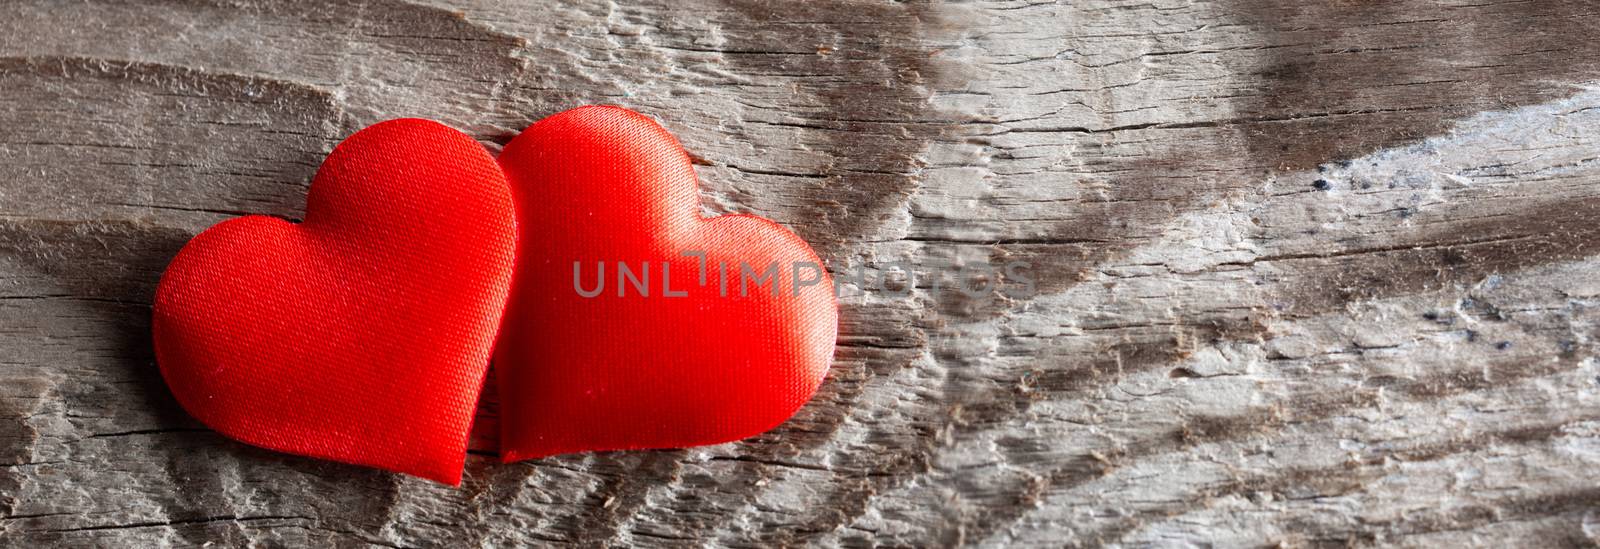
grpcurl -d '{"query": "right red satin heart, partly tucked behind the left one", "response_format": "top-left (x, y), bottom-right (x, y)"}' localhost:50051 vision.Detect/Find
top-left (494, 107), bottom-right (838, 461)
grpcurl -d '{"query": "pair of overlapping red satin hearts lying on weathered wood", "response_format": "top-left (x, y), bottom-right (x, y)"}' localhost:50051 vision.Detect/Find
top-left (154, 107), bottom-right (837, 483)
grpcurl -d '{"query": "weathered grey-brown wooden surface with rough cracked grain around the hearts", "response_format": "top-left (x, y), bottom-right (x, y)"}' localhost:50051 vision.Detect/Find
top-left (0, 0), bottom-right (1600, 546)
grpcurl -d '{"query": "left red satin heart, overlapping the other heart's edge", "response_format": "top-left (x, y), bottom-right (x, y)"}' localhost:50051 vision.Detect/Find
top-left (154, 118), bottom-right (515, 483)
